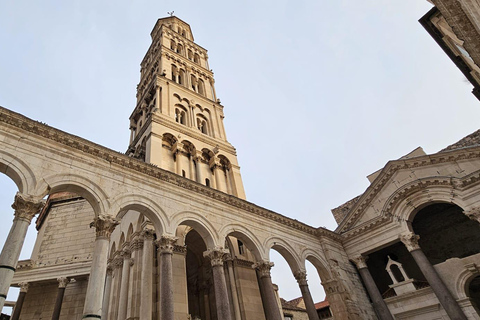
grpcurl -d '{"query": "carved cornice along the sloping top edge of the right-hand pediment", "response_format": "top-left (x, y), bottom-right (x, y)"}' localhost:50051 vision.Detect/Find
top-left (335, 147), bottom-right (480, 233)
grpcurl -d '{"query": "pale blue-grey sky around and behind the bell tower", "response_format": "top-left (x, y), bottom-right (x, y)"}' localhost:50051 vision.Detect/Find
top-left (0, 0), bottom-right (480, 310)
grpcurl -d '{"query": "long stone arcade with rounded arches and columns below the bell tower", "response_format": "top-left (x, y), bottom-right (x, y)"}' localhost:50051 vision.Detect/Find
top-left (0, 104), bottom-right (373, 319)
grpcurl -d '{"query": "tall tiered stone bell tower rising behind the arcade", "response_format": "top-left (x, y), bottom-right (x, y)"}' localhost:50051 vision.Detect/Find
top-left (127, 16), bottom-right (245, 199)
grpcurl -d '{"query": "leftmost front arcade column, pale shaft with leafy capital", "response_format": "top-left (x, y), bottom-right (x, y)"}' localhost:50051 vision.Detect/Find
top-left (0, 192), bottom-right (45, 310)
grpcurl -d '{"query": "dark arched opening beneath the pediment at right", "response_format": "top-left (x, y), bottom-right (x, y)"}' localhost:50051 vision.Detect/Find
top-left (412, 203), bottom-right (480, 264)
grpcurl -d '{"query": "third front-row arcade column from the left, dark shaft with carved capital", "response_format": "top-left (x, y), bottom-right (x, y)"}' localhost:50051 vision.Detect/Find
top-left (158, 236), bottom-right (177, 320)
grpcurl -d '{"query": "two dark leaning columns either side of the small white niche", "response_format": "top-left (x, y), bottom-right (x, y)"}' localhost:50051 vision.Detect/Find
top-left (353, 232), bottom-right (467, 320)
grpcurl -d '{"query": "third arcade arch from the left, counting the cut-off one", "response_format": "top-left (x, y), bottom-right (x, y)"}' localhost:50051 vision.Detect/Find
top-left (112, 194), bottom-right (168, 237)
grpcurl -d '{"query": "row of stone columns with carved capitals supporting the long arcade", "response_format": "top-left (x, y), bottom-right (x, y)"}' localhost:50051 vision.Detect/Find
top-left (0, 193), bottom-right (318, 320)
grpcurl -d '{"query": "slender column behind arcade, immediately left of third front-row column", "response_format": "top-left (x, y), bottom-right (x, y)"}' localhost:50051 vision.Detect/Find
top-left (140, 229), bottom-right (155, 320)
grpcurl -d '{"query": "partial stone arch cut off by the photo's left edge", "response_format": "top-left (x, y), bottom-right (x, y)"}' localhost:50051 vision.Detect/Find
top-left (0, 150), bottom-right (37, 195)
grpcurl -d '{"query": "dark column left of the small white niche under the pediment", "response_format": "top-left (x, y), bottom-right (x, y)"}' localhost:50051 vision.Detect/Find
top-left (353, 255), bottom-right (394, 320)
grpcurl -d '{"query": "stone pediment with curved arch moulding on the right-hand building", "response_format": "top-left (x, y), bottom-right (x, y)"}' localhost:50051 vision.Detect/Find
top-left (334, 146), bottom-right (480, 236)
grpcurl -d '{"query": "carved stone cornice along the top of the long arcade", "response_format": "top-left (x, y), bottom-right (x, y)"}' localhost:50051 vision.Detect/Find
top-left (0, 107), bottom-right (338, 240)
